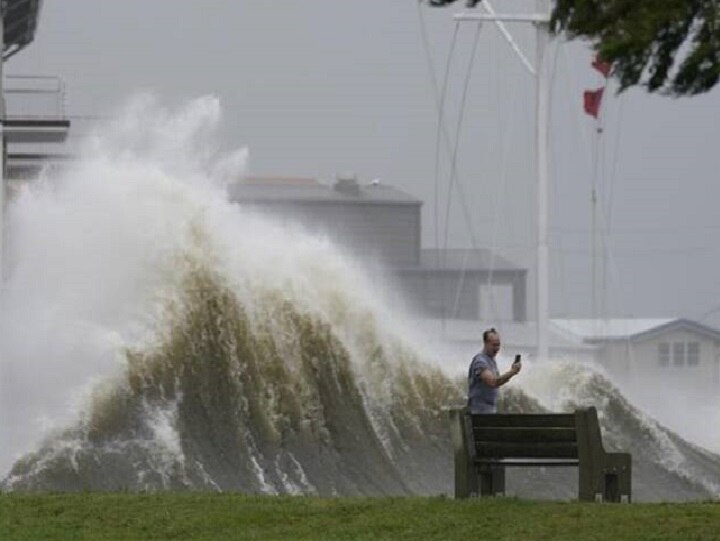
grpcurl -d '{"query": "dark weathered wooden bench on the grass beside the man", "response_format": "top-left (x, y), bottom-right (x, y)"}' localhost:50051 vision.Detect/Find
top-left (450, 408), bottom-right (632, 502)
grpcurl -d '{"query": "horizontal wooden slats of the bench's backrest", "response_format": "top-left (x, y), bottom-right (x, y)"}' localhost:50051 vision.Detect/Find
top-left (465, 413), bottom-right (578, 461)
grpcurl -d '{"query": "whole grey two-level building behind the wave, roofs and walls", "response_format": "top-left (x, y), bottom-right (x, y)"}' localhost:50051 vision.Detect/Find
top-left (228, 175), bottom-right (527, 322)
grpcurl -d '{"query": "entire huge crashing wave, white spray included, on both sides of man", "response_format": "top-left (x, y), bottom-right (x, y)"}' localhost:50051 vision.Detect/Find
top-left (0, 98), bottom-right (720, 499)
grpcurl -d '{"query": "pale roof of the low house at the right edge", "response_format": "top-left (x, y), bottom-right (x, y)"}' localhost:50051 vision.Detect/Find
top-left (552, 318), bottom-right (720, 342)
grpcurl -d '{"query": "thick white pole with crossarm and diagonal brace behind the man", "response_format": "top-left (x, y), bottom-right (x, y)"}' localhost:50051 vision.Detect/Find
top-left (455, 0), bottom-right (550, 360)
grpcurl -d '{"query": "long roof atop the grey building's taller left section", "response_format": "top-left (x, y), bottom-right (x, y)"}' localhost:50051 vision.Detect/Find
top-left (228, 177), bottom-right (422, 206)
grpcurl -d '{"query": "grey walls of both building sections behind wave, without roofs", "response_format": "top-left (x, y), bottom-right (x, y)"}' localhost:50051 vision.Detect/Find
top-left (235, 194), bottom-right (527, 322)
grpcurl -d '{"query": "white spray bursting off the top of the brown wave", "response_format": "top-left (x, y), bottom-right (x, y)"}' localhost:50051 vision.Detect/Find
top-left (0, 97), bottom-right (438, 471)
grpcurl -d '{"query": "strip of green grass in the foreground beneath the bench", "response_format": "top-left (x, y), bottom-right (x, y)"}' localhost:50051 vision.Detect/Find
top-left (0, 492), bottom-right (720, 541)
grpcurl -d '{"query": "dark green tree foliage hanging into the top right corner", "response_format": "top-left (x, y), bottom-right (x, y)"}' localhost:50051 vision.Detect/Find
top-left (550, 0), bottom-right (720, 96)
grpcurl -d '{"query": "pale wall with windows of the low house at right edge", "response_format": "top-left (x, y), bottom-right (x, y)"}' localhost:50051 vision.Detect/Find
top-left (600, 329), bottom-right (720, 389)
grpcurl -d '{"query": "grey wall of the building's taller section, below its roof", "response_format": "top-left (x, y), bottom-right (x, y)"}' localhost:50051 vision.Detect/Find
top-left (245, 201), bottom-right (420, 266)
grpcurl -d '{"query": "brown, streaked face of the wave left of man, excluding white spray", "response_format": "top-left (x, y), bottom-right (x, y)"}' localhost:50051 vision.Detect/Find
top-left (6, 263), bottom-right (459, 494)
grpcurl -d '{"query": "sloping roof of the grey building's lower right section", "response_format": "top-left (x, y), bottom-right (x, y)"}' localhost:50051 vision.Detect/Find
top-left (419, 248), bottom-right (527, 272)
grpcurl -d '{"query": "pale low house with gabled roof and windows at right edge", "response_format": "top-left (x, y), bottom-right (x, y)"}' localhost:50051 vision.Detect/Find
top-left (553, 319), bottom-right (720, 391)
